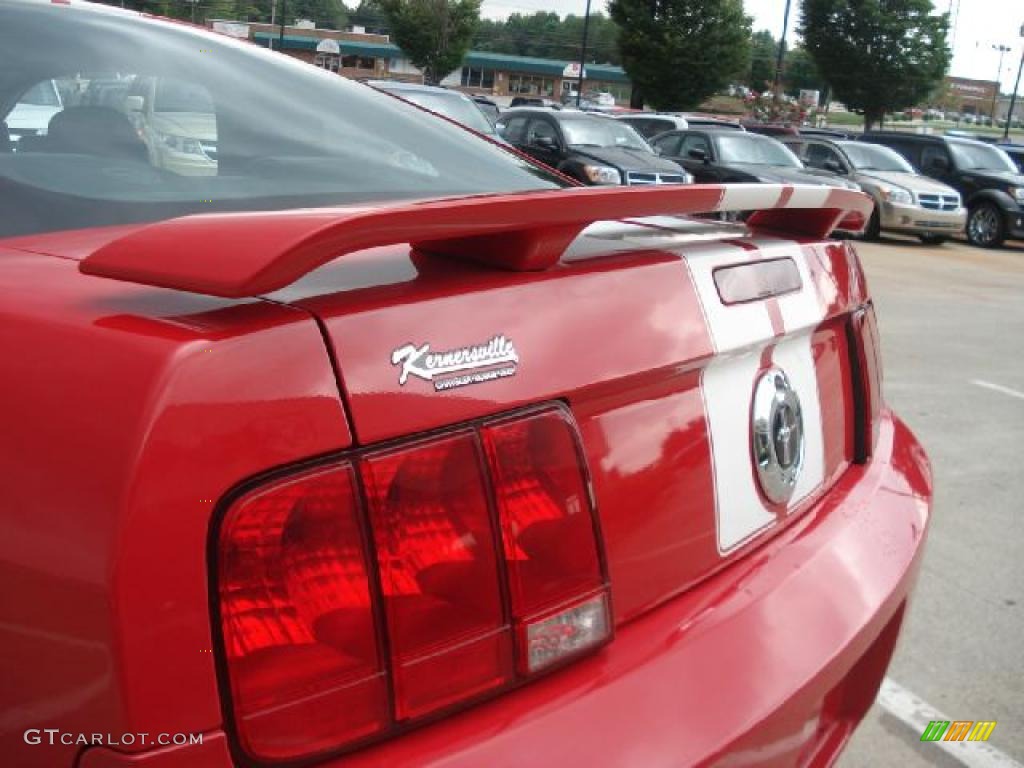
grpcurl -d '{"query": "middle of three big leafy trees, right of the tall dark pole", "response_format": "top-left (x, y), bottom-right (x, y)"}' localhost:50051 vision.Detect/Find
top-left (608, 0), bottom-right (751, 110)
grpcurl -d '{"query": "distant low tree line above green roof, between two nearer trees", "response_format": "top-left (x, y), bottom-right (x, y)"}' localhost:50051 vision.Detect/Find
top-left (473, 11), bottom-right (621, 65)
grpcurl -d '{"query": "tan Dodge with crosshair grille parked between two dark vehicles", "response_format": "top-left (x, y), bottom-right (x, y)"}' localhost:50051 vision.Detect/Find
top-left (782, 137), bottom-right (967, 245)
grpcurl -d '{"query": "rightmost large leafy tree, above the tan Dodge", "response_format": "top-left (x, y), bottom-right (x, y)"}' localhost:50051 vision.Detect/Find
top-left (800, 0), bottom-right (950, 129)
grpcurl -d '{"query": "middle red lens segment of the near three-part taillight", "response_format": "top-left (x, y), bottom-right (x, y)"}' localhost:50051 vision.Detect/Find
top-left (361, 432), bottom-right (512, 719)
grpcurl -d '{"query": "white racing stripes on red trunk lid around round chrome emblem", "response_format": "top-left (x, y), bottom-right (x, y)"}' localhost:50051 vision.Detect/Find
top-left (684, 242), bottom-right (824, 554)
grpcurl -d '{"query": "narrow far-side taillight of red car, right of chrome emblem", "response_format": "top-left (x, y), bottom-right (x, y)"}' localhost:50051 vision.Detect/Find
top-left (847, 304), bottom-right (882, 464)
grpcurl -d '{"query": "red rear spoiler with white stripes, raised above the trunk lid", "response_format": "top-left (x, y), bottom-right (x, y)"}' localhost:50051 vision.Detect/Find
top-left (79, 184), bottom-right (873, 298)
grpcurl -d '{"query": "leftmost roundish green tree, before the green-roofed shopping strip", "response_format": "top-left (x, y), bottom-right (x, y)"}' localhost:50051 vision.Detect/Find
top-left (380, 0), bottom-right (480, 83)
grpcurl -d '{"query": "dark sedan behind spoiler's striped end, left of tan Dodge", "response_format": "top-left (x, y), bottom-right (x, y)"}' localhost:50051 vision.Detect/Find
top-left (651, 130), bottom-right (857, 189)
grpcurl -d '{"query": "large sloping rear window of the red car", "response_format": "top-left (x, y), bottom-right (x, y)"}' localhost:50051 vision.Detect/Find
top-left (0, 2), bottom-right (566, 238)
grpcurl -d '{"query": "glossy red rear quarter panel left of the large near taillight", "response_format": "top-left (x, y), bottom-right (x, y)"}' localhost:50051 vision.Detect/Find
top-left (0, 245), bottom-right (351, 768)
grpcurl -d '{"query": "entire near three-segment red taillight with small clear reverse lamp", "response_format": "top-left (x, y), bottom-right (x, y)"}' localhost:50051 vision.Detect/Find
top-left (210, 407), bottom-right (611, 762)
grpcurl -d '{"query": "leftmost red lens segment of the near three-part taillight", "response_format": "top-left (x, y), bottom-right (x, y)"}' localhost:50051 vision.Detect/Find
top-left (219, 464), bottom-right (388, 759)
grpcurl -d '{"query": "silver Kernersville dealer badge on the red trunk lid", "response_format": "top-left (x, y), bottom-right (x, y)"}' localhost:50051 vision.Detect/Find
top-left (391, 334), bottom-right (519, 392)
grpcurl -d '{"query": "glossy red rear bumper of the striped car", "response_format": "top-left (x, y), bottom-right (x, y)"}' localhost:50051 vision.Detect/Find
top-left (80, 415), bottom-right (932, 768)
